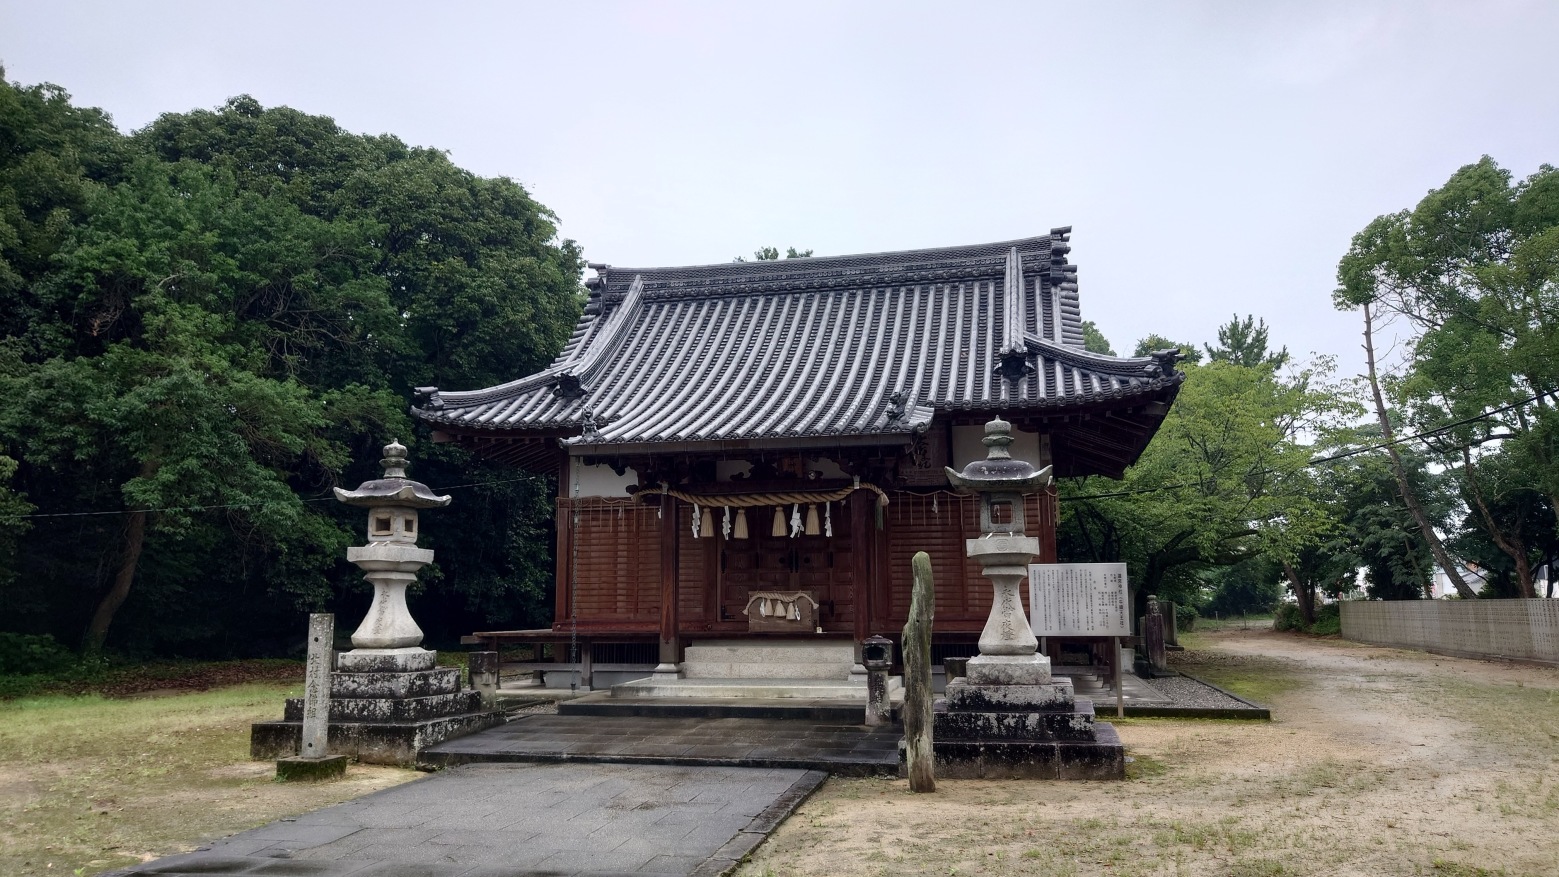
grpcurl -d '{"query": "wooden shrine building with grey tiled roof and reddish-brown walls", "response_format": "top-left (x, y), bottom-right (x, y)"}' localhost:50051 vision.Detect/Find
top-left (413, 227), bottom-right (1185, 688)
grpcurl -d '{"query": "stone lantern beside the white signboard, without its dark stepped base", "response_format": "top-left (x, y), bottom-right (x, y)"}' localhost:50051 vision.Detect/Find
top-left (948, 417), bottom-right (1051, 685)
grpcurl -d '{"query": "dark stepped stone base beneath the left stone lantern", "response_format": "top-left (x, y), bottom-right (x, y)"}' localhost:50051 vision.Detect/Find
top-left (249, 648), bottom-right (504, 766)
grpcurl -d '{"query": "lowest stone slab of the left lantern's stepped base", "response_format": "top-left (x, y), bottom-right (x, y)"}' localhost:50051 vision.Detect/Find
top-left (249, 712), bottom-right (504, 766)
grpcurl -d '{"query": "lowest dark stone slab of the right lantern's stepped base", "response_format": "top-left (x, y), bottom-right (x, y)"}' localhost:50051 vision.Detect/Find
top-left (932, 723), bottom-right (1126, 780)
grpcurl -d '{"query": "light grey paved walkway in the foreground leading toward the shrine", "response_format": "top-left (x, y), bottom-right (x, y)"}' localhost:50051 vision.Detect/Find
top-left (109, 763), bottom-right (826, 877)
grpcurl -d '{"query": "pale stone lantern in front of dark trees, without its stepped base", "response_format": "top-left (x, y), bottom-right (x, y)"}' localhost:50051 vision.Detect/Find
top-left (335, 439), bottom-right (449, 657)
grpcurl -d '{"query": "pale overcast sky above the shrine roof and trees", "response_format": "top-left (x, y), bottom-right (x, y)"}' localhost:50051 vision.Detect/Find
top-left (0, 0), bottom-right (1559, 381)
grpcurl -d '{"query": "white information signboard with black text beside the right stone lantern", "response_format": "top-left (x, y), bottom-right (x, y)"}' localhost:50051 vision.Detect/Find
top-left (1029, 564), bottom-right (1132, 637)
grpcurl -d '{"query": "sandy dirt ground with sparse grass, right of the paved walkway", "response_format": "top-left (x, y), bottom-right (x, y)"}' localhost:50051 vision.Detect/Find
top-left (739, 629), bottom-right (1559, 877)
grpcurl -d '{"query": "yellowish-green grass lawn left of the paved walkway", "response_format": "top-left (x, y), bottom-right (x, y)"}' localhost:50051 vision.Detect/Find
top-left (0, 682), bottom-right (419, 877)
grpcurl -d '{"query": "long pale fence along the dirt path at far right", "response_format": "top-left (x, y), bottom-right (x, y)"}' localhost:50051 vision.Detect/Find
top-left (1342, 598), bottom-right (1559, 665)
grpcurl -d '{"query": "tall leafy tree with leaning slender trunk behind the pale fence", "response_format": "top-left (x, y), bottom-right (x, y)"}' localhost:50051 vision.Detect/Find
top-left (1336, 156), bottom-right (1559, 597)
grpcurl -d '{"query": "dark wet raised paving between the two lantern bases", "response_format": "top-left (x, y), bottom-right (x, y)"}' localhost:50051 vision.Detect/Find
top-left (418, 713), bottom-right (904, 776)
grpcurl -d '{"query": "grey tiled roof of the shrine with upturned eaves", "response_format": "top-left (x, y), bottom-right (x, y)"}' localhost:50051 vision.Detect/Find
top-left (413, 229), bottom-right (1182, 446)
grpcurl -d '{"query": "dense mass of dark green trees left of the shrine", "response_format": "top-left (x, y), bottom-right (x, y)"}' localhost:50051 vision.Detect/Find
top-left (0, 86), bottom-right (582, 651)
